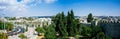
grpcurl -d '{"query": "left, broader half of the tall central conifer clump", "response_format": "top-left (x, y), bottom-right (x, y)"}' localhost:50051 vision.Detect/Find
top-left (53, 12), bottom-right (68, 36)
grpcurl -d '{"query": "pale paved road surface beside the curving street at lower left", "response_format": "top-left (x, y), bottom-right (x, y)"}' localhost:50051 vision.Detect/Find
top-left (8, 27), bottom-right (38, 39)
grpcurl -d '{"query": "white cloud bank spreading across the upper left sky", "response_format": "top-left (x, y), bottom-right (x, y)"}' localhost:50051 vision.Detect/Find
top-left (0, 0), bottom-right (57, 15)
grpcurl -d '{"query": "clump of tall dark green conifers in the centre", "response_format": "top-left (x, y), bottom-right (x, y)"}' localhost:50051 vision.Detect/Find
top-left (52, 10), bottom-right (80, 36)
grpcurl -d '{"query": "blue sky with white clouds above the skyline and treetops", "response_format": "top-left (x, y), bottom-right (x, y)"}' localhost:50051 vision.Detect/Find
top-left (0, 0), bottom-right (120, 16)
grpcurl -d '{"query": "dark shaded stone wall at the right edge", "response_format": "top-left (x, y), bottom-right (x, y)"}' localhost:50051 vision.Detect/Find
top-left (98, 21), bottom-right (120, 39)
